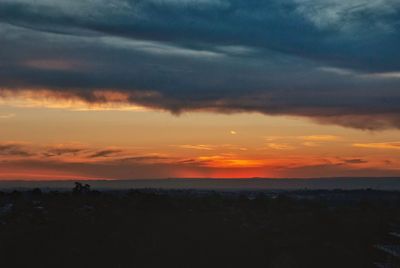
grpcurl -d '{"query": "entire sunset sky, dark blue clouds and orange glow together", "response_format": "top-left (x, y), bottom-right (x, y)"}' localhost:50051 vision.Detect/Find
top-left (0, 0), bottom-right (400, 180)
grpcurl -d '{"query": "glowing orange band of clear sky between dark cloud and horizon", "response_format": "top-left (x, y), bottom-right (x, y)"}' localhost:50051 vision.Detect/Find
top-left (0, 89), bottom-right (400, 180)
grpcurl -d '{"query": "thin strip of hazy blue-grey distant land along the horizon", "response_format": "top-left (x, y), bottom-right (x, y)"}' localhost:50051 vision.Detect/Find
top-left (0, 177), bottom-right (400, 190)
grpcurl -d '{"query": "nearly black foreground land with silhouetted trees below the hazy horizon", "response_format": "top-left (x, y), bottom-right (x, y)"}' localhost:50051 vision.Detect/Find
top-left (0, 184), bottom-right (400, 268)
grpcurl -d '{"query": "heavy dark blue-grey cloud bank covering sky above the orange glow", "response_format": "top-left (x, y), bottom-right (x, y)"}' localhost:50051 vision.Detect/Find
top-left (0, 0), bottom-right (400, 129)
